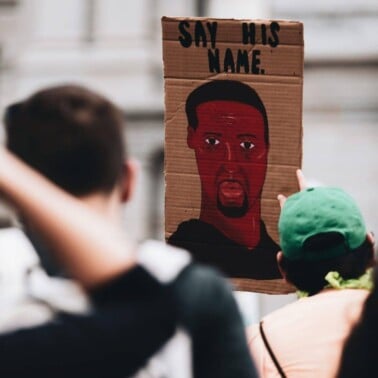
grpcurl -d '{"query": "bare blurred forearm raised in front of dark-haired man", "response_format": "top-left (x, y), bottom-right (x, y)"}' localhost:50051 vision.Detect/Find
top-left (0, 148), bottom-right (135, 289)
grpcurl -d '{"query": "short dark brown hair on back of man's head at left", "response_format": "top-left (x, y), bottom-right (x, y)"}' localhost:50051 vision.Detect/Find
top-left (5, 85), bottom-right (125, 196)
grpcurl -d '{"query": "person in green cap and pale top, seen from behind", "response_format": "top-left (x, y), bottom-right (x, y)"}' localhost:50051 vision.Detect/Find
top-left (247, 170), bottom-right (375, 378)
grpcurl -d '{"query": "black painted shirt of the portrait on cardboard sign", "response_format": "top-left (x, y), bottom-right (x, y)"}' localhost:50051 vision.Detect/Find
top-left (168, 219), bottom-right (281, 280)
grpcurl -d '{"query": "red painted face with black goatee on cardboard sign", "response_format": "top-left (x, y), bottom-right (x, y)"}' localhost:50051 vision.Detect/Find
top-left (188, 101), bottom-right (268, 217)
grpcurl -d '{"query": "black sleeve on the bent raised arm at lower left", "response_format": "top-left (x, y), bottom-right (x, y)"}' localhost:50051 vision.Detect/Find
top-left (0, 267), bottom-right (177, 378)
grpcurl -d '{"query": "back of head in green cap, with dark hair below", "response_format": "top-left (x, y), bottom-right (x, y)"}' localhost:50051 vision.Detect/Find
top-left (279, 187), bottom-right (373, 295)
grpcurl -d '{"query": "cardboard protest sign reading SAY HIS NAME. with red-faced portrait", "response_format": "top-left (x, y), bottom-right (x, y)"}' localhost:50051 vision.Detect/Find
top-left (162, 18), bottom-right (303, 293)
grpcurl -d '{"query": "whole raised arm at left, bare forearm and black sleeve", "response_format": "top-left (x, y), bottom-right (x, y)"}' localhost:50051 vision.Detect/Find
top-left (0, 149), bottom-right (176, 377)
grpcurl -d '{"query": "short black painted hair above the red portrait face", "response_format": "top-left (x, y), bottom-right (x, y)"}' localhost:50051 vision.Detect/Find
top-left (185, 80), bottom-right (269, 144)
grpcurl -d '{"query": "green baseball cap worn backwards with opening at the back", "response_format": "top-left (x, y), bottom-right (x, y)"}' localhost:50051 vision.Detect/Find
top-left (278, 187), bottom-right (367, 261)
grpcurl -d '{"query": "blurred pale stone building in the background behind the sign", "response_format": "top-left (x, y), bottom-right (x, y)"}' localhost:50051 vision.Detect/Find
top-left (0, 0), bottom-right (378, 321)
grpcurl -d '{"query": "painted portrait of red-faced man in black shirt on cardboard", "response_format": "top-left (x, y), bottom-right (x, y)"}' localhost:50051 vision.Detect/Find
top-left (168, 80), bottom-right (281, 280)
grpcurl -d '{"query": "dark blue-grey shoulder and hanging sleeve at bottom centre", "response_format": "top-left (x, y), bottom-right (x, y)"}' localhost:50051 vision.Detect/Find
top-left (171, 264), bottom-right (258, 378)
